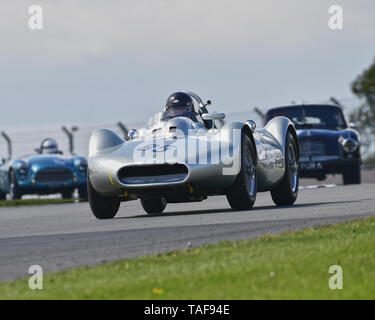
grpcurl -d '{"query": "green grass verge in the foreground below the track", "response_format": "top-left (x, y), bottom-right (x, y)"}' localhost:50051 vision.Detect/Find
top-left (0, 218), bottom-right (375, 299)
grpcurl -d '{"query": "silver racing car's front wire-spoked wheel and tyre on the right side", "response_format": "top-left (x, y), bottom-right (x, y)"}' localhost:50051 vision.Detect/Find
top-left (227, 133), bottom-right (257, 211)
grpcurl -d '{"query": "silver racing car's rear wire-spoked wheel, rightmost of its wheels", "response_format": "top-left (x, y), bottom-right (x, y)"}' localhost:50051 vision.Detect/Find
top-left (271, 132), bottom-right (299, 206)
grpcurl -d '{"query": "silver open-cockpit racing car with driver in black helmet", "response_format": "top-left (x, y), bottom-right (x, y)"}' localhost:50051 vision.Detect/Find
top-left (88, 91), bottom-right (299, 219)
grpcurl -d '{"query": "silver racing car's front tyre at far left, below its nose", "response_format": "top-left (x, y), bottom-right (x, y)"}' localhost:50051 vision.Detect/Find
top-left (87, 177), bottom-right (120, 219)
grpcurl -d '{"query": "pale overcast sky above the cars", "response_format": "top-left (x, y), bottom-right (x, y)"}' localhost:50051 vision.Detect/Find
top-left (0, 0), bottom-right (375, 127)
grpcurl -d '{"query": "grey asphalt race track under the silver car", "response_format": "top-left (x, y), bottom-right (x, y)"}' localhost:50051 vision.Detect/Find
top-left (0, 183), bottom-right (375, 281)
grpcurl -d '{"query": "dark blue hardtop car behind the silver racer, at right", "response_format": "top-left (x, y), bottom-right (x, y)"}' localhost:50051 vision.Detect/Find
top-left (265, 105), bottom-right (361, 184)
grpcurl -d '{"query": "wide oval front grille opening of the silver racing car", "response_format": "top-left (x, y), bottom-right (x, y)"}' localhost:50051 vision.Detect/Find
top-left (118, 164), bottom-right (188, 184)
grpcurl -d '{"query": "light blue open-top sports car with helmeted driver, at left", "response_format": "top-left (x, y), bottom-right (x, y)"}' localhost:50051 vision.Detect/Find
top-left (0, 138), bottom-right (87, 200)
